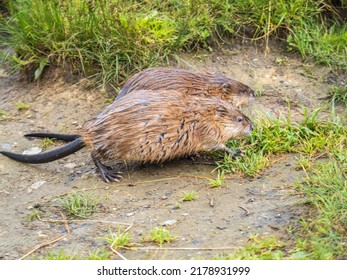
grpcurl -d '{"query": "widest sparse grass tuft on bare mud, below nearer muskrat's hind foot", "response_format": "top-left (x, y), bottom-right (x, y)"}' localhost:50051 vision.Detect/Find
top-left (60, 192), bottom-right (101, 219)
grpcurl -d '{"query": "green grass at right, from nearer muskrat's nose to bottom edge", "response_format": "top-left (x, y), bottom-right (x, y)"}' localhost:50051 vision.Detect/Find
top-left (216, 106), bottom-right (347, 259)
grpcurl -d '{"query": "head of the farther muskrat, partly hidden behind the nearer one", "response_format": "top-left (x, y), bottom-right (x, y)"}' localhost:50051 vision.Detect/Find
top-left (222, 81), bottom-right (255, 107)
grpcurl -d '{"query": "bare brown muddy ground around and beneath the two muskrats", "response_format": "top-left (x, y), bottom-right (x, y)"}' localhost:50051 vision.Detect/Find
top-left (0, 42), bottom-right (344, 259)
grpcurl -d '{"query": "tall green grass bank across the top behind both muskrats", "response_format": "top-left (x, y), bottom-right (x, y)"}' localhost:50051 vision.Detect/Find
top-left (0, 0), bottom-right (347, 86)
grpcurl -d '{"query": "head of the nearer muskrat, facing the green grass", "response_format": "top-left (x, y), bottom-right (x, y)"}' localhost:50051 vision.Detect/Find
top-left (216, 106), bottom-right (254, 140)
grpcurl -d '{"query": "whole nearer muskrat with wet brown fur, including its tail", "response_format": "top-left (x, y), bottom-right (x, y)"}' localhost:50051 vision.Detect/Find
top-left (0, 90), bottom-right (253, 182)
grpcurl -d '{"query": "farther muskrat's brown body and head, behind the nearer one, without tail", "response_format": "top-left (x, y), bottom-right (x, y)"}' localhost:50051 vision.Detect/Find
top-left (116, 67), bottom-right (255, 107)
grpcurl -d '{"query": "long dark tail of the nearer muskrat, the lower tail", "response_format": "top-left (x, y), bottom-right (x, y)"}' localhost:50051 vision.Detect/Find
top-left (0, 138), bottom-right (85, 164)
